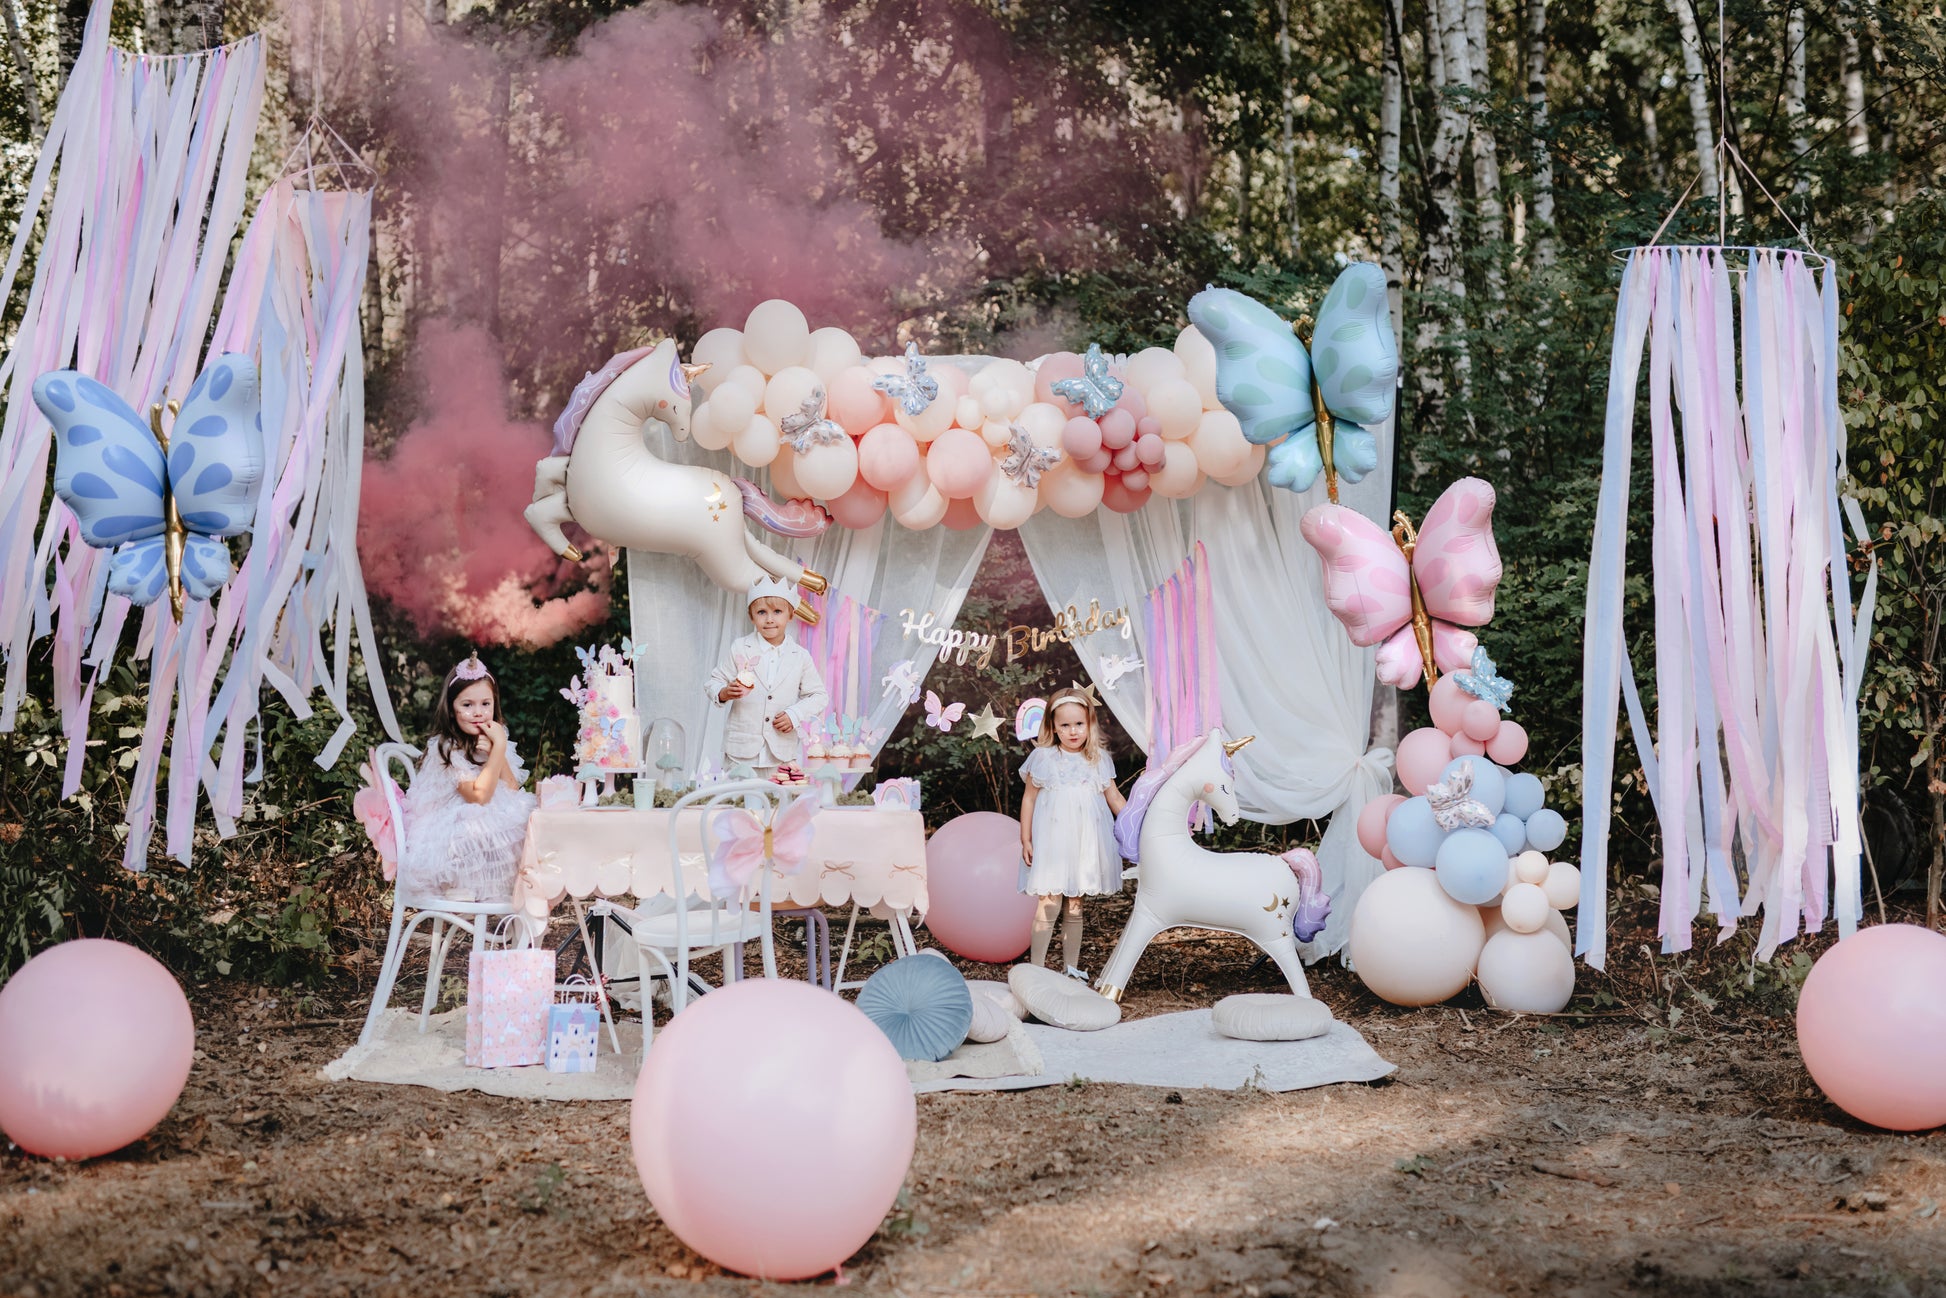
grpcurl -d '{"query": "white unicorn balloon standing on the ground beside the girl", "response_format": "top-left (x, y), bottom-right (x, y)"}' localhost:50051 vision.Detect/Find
top-left (1096, 730), bottom-right (1331, 1000)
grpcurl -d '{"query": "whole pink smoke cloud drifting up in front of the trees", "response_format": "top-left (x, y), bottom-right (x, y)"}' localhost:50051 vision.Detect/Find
top-left (286, 0), bottom-right (1171, 642)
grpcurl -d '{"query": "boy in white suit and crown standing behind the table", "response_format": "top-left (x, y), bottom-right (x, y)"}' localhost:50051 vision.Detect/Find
top-left (704, 578), bottom-right (829, 778)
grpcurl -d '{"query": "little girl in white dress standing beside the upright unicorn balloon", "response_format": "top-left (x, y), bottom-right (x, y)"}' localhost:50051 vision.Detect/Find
top-left (1020, 689), bottom-right (1123, 977)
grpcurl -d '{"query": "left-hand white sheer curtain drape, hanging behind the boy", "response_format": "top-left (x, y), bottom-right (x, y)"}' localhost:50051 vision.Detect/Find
top-left (629, 424), bottom-right (992, 776)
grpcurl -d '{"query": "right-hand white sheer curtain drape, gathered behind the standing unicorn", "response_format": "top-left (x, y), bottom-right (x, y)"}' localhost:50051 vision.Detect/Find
top-left (1020, 457), bottom-right (1391, 959)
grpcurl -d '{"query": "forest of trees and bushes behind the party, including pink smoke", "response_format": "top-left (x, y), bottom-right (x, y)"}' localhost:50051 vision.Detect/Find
top-left (0, 0), bottom-right (1946, 983)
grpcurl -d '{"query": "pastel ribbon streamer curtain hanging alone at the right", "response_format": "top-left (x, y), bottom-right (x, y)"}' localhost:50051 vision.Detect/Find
top-left (1576, 247), bottom-right (1878, 967)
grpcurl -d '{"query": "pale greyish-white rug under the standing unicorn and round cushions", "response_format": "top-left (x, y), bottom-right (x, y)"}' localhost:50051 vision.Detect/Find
top-left (913, 1010), bottom-right (1397, 1092)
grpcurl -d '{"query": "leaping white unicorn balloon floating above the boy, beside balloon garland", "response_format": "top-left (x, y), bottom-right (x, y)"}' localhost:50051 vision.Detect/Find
top-left (527, 341), bottom-right (831, 623)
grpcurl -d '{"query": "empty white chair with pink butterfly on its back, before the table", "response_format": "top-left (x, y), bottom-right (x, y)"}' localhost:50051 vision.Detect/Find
top-left (590, 780), bottom-right (798, 1053)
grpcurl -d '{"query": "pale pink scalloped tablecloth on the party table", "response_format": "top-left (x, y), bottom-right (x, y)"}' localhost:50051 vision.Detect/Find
top-left (522, 808), bottom-right (926, 913)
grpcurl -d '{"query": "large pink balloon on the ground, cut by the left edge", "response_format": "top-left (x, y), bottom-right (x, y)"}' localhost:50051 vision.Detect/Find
top-left (0, 938), bottom-right (197, 1158)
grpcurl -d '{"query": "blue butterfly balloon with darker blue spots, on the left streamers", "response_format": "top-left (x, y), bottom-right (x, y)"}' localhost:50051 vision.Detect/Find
top-left (33, 352), bottom-right (263, 621)
